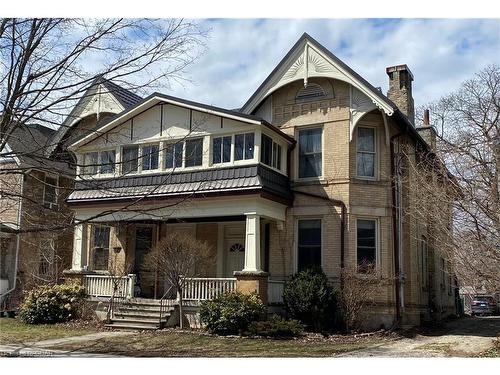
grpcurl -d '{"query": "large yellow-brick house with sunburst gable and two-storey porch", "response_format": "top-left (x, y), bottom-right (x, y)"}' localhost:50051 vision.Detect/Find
top-left (63, 34), bottom-right (456, 328)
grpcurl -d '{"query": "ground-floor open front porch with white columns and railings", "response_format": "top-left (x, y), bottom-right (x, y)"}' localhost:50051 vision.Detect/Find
top-left (69, 213), bottom-right (284, 304)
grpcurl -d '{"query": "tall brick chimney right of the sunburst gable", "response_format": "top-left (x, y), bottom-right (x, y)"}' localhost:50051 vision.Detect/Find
top-left (385, 64), bottom-right (415, 125)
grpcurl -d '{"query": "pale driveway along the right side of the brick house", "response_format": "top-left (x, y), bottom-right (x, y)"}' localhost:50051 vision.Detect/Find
top-left (341, 316), bottom-right (500, 357)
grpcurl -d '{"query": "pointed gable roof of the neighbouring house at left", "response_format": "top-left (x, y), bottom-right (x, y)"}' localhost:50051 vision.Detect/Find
top-left (48, 77), bottom-right (142, 155)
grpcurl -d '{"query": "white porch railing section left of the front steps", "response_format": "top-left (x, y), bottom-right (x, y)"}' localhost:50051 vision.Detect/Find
top-left (83, 275), bottom-right (135, 298)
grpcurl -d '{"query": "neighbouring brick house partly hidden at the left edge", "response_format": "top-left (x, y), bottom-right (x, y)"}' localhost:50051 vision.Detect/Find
top-left (0, 78), bottom-right (141, 309)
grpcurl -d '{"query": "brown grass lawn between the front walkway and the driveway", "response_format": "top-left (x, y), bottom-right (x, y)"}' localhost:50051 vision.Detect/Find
top-left (48, 330), bottom-right (393, 357)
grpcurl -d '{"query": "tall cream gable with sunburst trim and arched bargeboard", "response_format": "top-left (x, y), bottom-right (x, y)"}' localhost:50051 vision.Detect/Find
top-left (241, 33), bottom-right (397, 116)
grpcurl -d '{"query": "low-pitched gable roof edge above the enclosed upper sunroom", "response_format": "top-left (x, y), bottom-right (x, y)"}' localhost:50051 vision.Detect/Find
top-left (70, 92), bottom-right (295, 148)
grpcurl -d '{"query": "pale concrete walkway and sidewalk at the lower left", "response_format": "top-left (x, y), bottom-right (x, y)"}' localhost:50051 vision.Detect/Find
top-left (0, 331), bottom-right (134, 358)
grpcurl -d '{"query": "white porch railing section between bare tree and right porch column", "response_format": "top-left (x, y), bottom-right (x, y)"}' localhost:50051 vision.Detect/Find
top-left (182, 277), bottom-right (236, 301)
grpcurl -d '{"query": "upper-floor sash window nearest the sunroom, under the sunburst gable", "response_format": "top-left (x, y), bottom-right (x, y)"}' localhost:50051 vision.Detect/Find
top-left (299, 128), bottom-right (323, 178)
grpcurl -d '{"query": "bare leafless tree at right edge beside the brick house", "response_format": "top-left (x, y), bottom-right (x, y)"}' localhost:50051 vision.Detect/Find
top-left (414, 65), bottom-right (500, 292)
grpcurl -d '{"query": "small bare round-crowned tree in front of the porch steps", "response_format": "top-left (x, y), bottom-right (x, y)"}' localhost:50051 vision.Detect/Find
top-left (145, 232), bottom-right (215, 329)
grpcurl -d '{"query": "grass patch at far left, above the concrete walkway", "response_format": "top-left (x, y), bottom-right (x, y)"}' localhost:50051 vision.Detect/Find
top-left (0, 318), bottom-right (97, 344)
